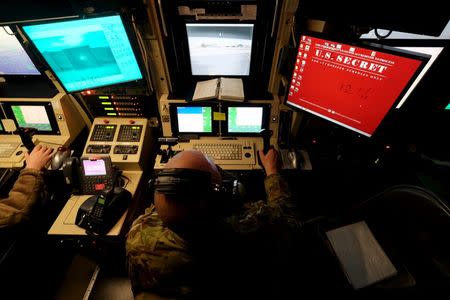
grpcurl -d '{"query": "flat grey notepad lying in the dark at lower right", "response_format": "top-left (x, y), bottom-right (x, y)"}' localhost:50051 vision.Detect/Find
top-left (326, 221), bottom-right (397, 289)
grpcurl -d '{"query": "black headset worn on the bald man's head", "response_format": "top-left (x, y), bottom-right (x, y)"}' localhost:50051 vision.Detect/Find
top-left (149, 166), bottom-right (245, 204)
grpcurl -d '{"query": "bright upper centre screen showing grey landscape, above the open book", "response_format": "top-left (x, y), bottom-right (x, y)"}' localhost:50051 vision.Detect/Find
top-left (186, 23), bottom-right (254, 76)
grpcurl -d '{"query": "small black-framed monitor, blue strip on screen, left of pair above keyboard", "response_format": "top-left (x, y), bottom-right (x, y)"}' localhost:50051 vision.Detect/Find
top-left (170, 103), bottom-right (217, 136)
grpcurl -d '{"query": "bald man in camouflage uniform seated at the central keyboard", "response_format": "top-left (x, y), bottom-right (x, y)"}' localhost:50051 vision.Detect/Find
top-left (126, 149), bottom-right (299, 299)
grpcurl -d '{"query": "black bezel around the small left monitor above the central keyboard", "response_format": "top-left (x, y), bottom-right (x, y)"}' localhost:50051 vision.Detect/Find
top-left (169, 102), bottom-right (219, 136)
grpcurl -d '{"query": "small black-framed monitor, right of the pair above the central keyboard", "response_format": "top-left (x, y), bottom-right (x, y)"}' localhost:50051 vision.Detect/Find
top-left (222, 104), bottom-right (270, 136)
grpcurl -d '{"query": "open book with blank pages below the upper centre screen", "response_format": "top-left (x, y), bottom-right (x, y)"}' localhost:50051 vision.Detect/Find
top-left (192, 77), bottom-right (245, 101)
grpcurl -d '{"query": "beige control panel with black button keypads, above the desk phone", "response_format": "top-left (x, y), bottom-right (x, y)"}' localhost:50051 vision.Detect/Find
top-left (83, 118), bottom-right (150, 170)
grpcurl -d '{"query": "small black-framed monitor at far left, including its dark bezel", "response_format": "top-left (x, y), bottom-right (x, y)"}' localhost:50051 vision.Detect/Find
top-left (3, 101), bottom-right (60, 134)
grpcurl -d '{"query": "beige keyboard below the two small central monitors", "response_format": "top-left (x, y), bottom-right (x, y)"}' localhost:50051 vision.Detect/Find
top-left (190, 140), bottom-right (256, 165)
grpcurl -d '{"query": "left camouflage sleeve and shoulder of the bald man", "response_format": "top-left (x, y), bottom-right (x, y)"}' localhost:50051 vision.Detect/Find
top-left (126, 207), bottom-right (192, 296)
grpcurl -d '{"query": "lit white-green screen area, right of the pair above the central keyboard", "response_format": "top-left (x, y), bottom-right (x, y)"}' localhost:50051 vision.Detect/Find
top-left (228, 107), bottom-right (263, 133)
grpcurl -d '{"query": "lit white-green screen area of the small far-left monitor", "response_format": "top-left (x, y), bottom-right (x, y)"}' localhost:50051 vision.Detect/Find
top-left (11, 105), bottom-right (52, 131)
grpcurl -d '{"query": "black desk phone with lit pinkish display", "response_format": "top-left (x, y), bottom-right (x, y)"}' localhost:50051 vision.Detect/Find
top-left (63, 156), bottom-right (118, 195)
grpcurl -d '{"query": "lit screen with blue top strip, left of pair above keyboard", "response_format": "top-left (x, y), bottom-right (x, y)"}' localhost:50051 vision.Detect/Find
top-left (177, 106), bottom-right (212, 133)
